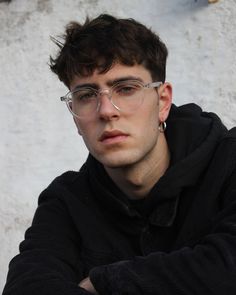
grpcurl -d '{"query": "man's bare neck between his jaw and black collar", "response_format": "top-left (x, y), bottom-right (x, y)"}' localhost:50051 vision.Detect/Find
top-left (105, 133), bottom-right (170, 199)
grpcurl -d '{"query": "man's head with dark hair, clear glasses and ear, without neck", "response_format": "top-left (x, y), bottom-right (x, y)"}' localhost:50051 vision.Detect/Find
top-left (51, 15), bottom-right (172, 169)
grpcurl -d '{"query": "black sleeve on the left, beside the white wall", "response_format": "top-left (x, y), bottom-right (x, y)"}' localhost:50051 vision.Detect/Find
top-left (3, 185), bottom-right (90, 295)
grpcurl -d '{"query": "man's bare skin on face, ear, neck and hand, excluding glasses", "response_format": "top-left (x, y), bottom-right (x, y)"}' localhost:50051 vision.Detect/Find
top-left (70, 64), bottom-right (172, 294)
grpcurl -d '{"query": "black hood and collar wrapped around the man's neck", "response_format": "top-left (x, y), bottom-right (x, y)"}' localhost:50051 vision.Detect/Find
top-left (86, 104), bottom-right (227, 230)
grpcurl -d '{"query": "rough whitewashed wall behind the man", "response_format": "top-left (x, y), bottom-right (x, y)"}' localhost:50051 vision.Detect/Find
top-left (0, 0), bottom-right (236, 290)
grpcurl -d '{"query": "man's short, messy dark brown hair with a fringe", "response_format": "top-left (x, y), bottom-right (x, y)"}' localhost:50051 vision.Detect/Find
top-left (49, 14), bottom-right (168, 88)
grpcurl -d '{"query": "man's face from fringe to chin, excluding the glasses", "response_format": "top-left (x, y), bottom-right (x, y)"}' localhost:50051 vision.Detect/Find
top-left (70, 64), bottom-right (171, 168)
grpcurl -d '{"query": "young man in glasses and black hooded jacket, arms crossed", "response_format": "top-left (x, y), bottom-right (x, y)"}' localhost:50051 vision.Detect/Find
top-left (3, 15), bottom-right (236, 295)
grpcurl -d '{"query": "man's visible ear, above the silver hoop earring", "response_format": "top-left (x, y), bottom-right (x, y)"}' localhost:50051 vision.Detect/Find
top-left (158, 82), bottom-right (172, 122)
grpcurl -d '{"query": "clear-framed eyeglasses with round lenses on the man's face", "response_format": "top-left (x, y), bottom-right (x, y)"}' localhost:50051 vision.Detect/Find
top-left (61, 80), bottom-right (162, 118)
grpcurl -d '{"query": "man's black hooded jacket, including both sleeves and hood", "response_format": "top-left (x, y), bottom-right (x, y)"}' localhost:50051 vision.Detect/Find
top-left (3, 104), bottom-right (236, 295)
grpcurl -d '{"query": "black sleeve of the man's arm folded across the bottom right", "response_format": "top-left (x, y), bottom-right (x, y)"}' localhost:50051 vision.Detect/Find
top-left (90, 171), bottom-right (236, 295)
